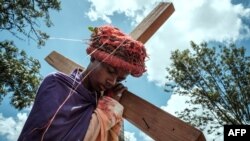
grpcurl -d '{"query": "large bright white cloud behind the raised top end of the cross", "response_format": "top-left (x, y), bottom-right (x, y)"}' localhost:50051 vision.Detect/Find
top-left (86, 0), bottom-right (250, 85)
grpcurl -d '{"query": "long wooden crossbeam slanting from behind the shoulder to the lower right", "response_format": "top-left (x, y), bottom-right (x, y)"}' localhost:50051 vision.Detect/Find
top-left (45, 51), bottom-right (205, 141)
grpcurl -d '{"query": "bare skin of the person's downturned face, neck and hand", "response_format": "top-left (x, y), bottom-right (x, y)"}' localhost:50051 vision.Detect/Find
top-left (83, 58), bottom-right (129, 101)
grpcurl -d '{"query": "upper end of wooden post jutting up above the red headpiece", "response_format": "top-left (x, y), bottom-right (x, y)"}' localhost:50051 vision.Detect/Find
top-left (129, 2), bottom-right (174, 43)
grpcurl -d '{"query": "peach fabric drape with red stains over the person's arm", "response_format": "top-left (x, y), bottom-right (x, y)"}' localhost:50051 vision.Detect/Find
top-left (84, 96), bottom-right (123, 141)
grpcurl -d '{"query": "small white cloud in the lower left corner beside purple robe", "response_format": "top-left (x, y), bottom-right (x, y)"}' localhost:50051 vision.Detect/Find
top-left (0, 113), bottom-right (27, 141)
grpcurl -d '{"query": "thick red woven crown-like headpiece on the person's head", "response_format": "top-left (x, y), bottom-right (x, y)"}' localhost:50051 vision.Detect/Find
top-left (86, 25), bottom-right (147, 77)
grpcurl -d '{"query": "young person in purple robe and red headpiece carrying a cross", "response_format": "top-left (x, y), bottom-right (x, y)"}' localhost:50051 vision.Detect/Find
top-left (18, 25), bottom-right (147, 141)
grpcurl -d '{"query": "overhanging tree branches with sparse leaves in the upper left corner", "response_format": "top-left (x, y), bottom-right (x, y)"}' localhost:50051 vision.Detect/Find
top-left (0, 0), bottom-right (60, 46)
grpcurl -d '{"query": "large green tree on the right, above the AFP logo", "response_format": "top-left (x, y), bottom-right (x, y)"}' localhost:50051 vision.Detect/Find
top-left (166, 42), bottom-right (250, 134)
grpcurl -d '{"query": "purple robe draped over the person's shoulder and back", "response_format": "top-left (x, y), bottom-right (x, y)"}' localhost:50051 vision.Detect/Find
top-left (18, 71), bottom-right (97, 141)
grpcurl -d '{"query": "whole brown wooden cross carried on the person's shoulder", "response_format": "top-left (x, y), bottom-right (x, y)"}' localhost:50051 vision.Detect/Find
top-left (45, 2), bottom-right (205, 141)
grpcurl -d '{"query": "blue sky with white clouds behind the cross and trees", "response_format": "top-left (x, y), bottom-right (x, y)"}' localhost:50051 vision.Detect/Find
top-left (0, 0), bottom-right (250, 141)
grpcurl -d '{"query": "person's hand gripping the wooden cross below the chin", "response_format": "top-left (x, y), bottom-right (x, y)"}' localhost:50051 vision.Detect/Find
top-left (105, 83), bottom-right (128, 101)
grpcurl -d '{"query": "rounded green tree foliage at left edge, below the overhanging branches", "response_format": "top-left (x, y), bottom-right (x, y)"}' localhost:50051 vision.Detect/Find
top-left (0, 41), bottom-right (41, 110)
